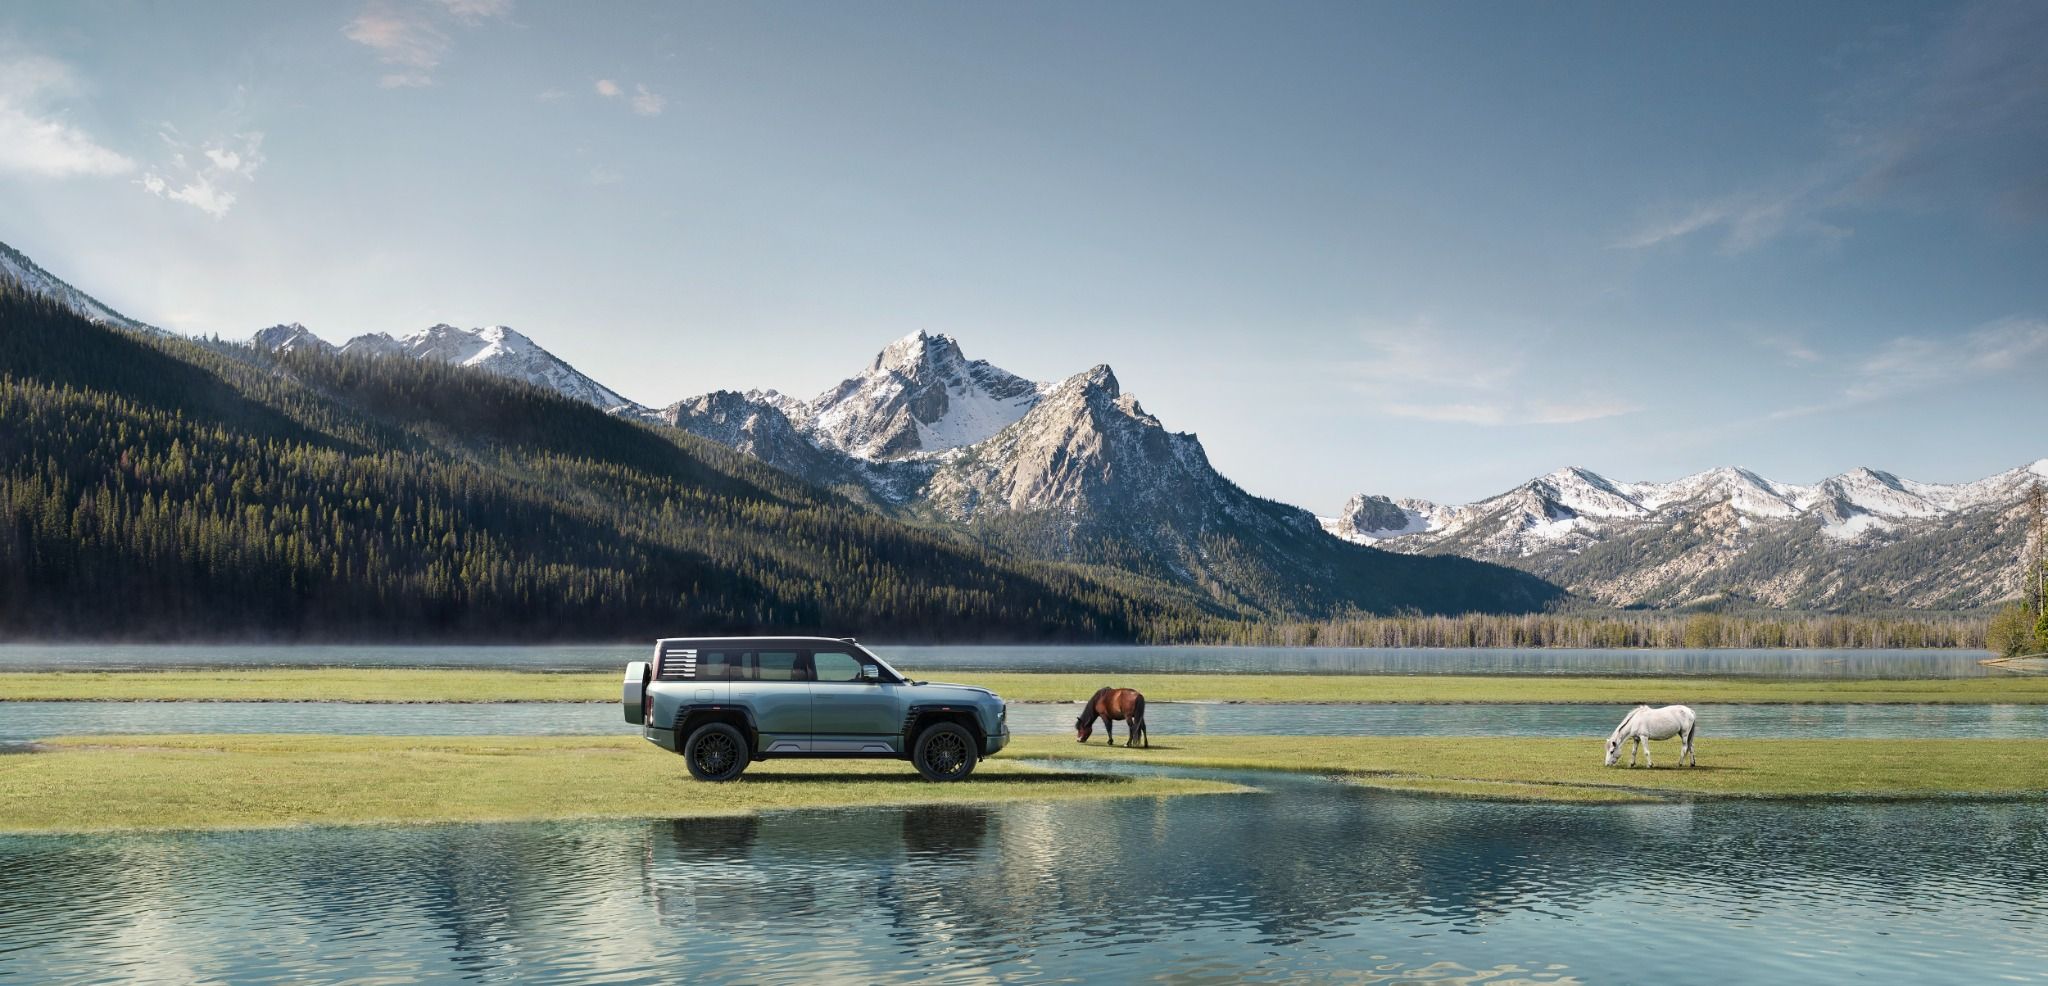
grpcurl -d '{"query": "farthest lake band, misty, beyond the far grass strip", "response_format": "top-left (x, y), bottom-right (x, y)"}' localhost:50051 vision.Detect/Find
top-left (0, 644), bottom-right (1991, 679)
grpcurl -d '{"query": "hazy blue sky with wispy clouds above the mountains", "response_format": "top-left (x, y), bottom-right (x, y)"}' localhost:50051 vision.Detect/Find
top-left (0, 0), bottom-right (2048, 512)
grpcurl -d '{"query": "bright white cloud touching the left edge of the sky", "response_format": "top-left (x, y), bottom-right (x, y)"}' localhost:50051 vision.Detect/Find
top-left (0, 55), bottom-right (135, 178)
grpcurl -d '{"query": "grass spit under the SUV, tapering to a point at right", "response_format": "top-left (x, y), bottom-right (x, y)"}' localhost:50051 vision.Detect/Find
top-left (0, 736), bottom-right (1231, 832)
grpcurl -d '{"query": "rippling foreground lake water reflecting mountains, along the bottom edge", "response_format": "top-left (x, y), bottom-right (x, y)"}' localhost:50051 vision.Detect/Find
top-left (0, 775), bottom-right (2048, 984)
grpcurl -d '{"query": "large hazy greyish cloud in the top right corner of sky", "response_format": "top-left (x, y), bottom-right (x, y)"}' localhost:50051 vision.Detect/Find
top-left (1612, 0), bottom-right (2048, 254)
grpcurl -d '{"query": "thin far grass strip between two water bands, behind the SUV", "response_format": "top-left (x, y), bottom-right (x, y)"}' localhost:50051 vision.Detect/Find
top-left (0, 668), bottom-right (2048, 705)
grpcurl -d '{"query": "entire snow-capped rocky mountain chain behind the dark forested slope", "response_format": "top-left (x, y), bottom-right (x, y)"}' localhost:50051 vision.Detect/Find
top-left (12, 233), bottom-right (2048, 615)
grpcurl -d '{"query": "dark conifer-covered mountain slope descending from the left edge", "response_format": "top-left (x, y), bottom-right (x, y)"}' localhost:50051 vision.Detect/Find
top-left (0, 285), bottom-right (1206, 640)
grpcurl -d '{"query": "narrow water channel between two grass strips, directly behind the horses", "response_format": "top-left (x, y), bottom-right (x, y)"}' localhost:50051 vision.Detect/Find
top-left (0, 701), bottom-right (2048, 744)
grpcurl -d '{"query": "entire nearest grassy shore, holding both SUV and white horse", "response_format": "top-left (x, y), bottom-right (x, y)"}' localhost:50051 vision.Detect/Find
top-left (0, 734), bottom-right (2048, 836)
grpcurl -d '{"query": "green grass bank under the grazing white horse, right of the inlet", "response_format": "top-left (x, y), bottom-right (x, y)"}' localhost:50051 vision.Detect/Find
top-left (1008, 736), bottom-right (2048, 802)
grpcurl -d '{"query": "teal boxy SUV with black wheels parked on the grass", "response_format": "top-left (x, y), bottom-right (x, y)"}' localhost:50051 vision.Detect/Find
top-left (621, 638), bottom-right (1010, 781)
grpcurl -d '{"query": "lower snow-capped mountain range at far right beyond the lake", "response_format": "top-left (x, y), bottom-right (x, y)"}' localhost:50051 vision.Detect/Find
top-left (1323, 459), bottom-right (2048, 609)
